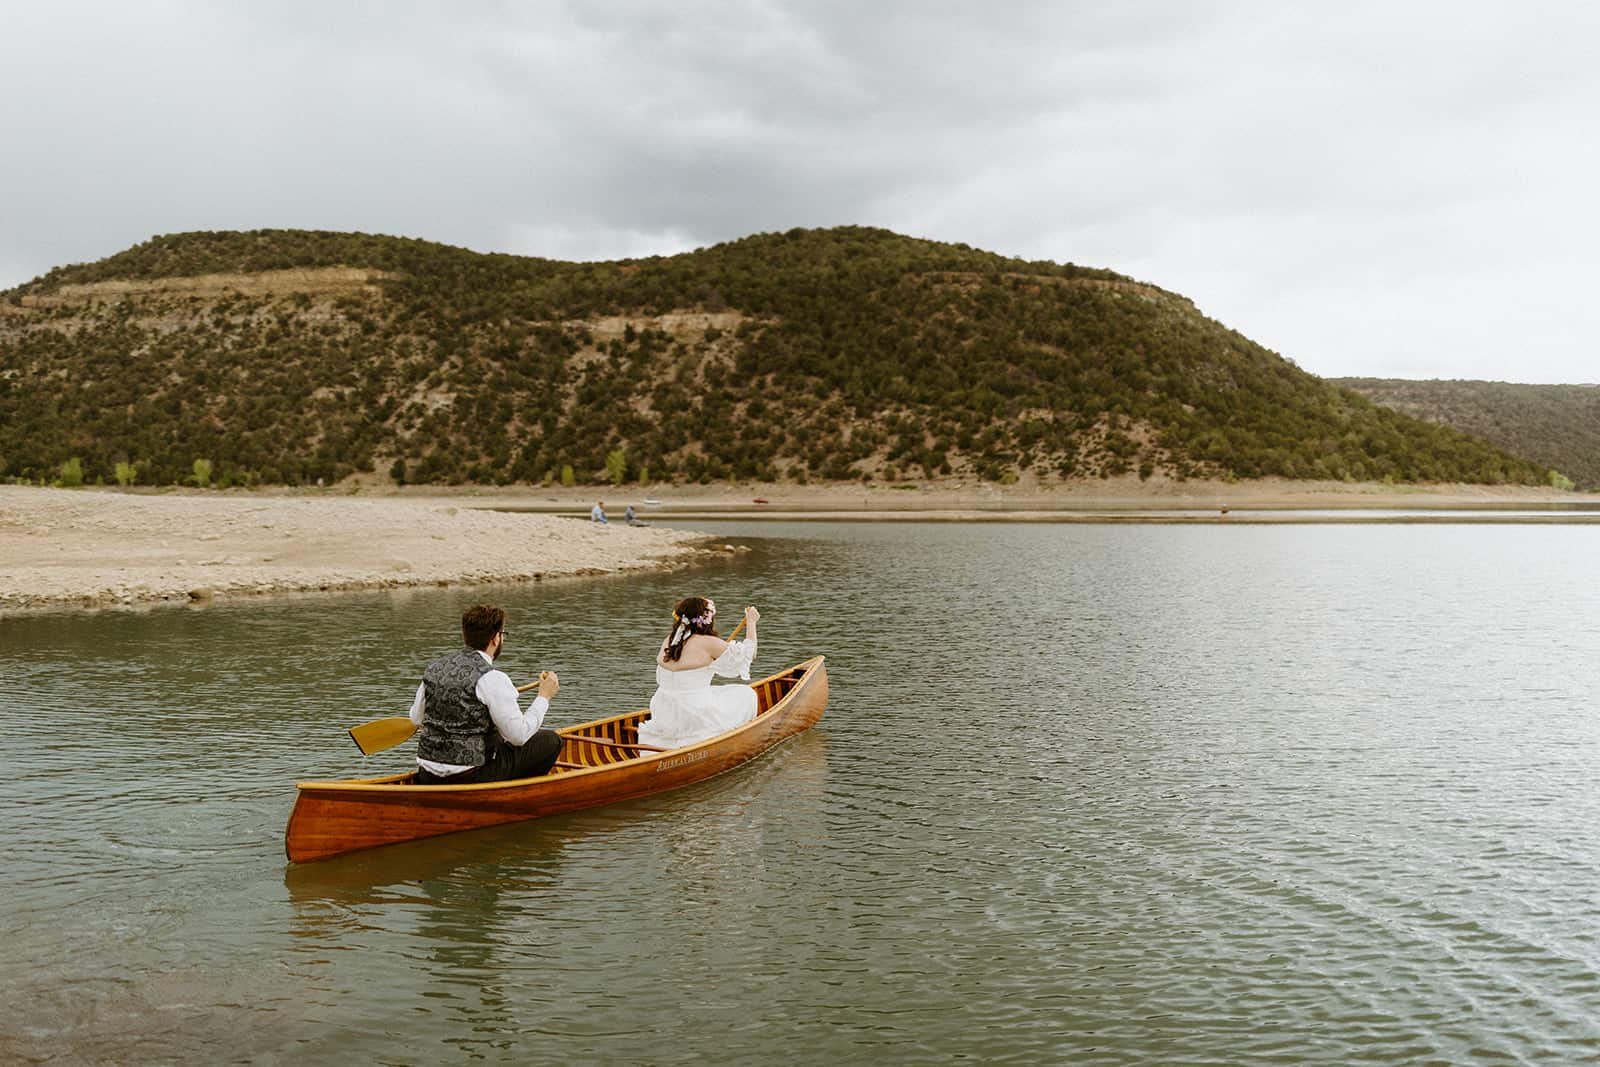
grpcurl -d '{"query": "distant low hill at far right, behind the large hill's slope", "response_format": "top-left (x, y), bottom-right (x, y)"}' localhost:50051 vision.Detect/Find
top-left (1334, 378), bottom-right (1600, 490)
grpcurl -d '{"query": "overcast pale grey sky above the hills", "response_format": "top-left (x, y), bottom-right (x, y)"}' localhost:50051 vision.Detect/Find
top-left (0, 0), bottom-right (1600, 382)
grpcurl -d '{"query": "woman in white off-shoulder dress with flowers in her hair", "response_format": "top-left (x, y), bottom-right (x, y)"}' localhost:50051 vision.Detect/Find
top-left (638, 597), bottom-right (762, 749)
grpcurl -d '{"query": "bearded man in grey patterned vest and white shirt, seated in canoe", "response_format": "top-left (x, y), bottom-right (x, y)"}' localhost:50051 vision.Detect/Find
top-left (411, 605), bottom-right (562, 785)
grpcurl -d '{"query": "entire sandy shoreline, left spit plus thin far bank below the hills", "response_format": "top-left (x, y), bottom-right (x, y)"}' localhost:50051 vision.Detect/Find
top-left (0, 480), bottom-right (1600, 611)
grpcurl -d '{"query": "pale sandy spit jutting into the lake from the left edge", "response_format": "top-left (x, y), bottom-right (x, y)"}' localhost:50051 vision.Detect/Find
top-left (0, 486), bottom-right (720, 611)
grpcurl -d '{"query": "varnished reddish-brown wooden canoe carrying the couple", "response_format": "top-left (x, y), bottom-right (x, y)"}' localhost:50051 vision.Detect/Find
top-left (283, 656), bottom-right (827, 862)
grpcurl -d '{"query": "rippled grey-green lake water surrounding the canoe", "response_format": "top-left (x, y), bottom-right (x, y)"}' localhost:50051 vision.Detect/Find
top-left (0, 523), bottom-right (1600, 1064)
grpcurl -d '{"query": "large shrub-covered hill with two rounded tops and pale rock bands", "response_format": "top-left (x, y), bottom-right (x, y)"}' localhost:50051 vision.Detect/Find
top-left (0, 227), bottom-right (1546, 485)
